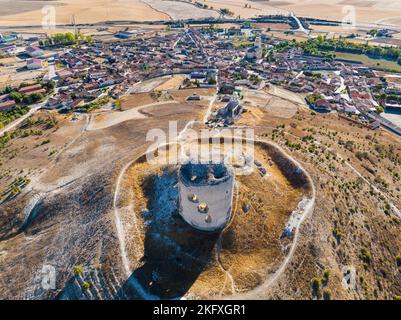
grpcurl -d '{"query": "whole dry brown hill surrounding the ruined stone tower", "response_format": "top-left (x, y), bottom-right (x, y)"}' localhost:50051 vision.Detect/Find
top-left (0, 77), bottom-right (401, 299)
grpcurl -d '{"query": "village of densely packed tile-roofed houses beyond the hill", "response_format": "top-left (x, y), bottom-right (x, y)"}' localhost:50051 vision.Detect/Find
top-left (0, 24), bottom-right (401, 134)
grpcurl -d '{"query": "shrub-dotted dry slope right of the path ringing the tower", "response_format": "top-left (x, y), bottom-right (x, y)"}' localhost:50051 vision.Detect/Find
top-left (247, 111), bottom-right (401, 299)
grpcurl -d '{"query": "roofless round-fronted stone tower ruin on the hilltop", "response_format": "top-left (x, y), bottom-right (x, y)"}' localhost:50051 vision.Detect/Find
top-left (178, 162), bottom-right (234, 231)
